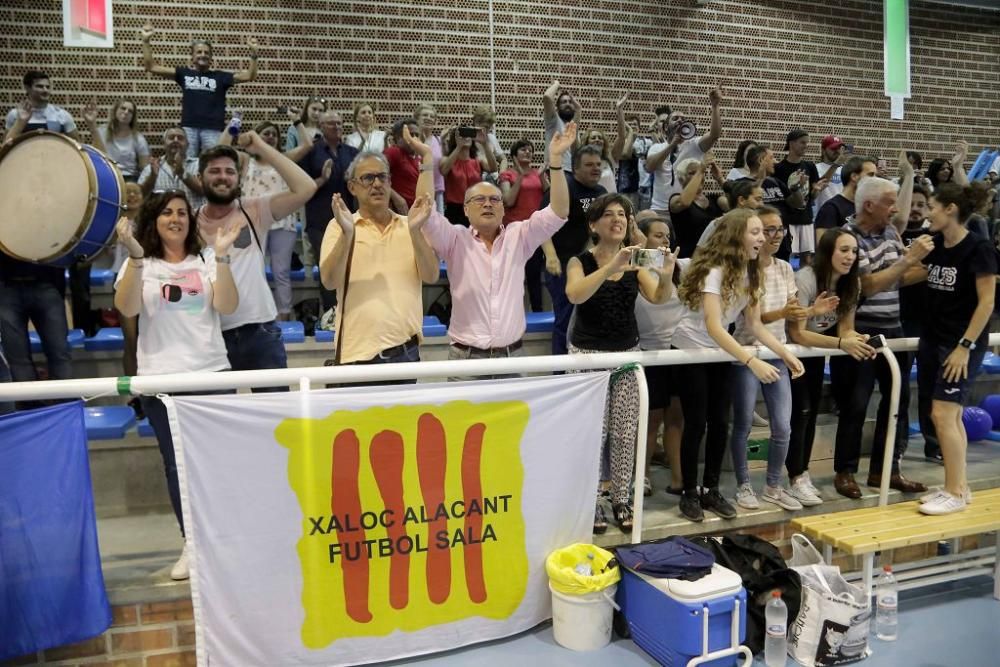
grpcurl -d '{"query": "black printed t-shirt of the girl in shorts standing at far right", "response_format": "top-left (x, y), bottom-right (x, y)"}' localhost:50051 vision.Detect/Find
top-left (924, 233), bottom-right (997, 344)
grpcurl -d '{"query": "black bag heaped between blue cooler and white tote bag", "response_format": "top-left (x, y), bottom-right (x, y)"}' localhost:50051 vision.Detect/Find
top-left (691, 535), bottom-right (802, 655)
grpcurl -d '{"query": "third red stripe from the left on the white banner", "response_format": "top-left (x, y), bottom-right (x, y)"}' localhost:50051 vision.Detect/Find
top-left (417, 413), bottom-right (451, 604)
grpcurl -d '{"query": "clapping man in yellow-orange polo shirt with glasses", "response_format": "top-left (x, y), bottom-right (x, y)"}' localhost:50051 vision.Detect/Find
top-left (319, 152), bottom-right (439, 380)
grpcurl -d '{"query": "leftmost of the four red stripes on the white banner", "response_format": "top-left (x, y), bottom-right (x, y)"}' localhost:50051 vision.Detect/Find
top-left (330, 430), bottom-right (372, 623)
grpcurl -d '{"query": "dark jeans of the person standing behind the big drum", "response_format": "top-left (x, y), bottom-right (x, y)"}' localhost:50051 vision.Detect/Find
top-left (0, 282), bottom-right (73, 382)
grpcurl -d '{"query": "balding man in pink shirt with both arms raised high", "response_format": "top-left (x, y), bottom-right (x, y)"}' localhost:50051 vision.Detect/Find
top-left (404, 122), bottom-right (576, 374)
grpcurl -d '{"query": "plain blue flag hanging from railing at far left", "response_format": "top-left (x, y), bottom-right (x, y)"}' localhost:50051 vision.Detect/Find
top-left (0, 402), bottom-right (111, 660)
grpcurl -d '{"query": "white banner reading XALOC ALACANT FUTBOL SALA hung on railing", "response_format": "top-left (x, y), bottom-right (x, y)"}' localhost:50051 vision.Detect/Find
top-left (165, 372), bottom-right (609, 667)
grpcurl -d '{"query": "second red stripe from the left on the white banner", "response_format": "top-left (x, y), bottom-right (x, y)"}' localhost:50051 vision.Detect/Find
top-left (369, 431), bottom-right (410, 609)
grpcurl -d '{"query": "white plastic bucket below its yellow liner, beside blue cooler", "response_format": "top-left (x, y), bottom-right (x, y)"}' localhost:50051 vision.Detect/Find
top-left (549, 584), bottom-right (617, 651)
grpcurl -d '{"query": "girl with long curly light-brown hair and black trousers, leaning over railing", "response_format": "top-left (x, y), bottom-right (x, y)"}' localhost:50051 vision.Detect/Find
top-left (670, 209), bottom-right (802, 521)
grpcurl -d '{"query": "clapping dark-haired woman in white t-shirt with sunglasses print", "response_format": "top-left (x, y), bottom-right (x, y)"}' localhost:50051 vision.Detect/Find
top-left (115, 191), bottom-right (246, 579)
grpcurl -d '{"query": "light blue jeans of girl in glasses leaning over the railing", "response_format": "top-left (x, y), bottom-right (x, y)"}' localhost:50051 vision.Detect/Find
top-left (729, 360), bottom-right (792, 486)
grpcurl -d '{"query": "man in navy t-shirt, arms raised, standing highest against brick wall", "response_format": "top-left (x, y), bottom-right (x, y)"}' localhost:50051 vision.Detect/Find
top-left (139, 22), bottom-right (257, 157)
